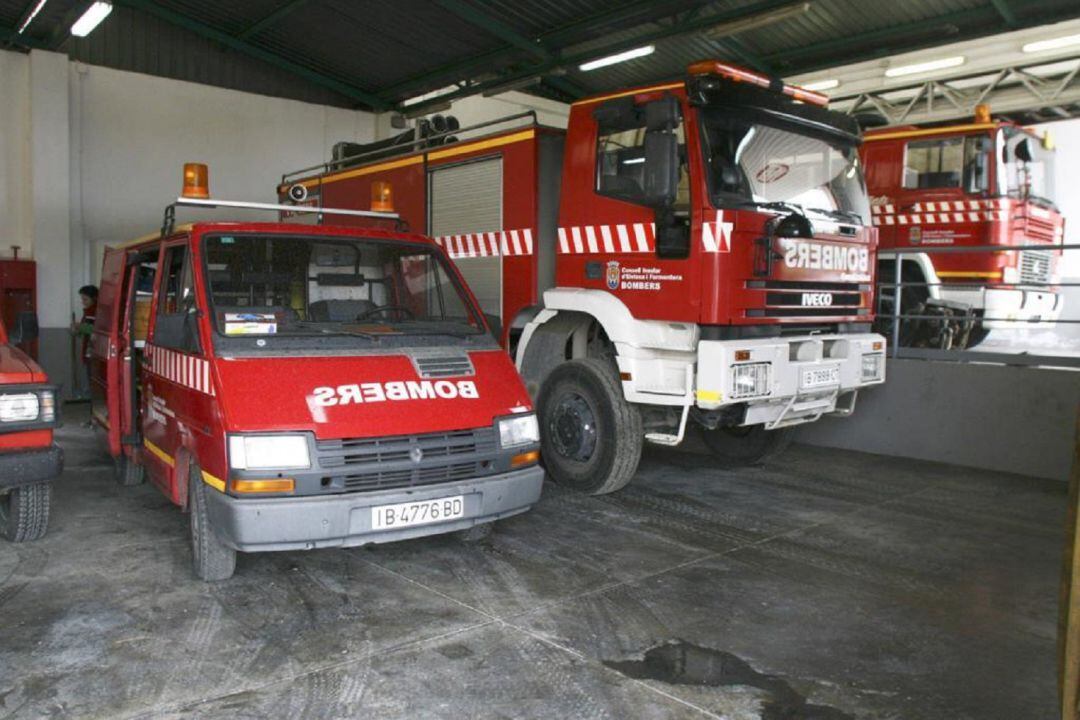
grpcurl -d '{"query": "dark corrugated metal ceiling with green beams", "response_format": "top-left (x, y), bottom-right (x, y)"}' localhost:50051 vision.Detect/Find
top-left (0, 0), bottom-right (1080, 109)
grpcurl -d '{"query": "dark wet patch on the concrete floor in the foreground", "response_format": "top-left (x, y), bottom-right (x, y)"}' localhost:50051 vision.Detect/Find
top-left (604, 640), bottom-right (855, 720)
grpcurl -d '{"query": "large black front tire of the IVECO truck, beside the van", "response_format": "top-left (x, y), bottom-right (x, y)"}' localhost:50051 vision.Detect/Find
top-left (538, 357), bottom-right (644, 495)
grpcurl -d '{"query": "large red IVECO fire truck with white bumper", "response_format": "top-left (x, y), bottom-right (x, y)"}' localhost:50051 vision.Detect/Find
top-left (279, 60), bottom-right (885, 493)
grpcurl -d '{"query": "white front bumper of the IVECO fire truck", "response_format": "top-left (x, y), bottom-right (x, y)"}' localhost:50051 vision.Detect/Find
top-left (696, 332), bottom-right (886, 430)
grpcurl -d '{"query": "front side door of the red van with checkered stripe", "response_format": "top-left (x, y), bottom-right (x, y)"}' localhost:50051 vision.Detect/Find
top-left (139, 242), bottom-right (200, 497)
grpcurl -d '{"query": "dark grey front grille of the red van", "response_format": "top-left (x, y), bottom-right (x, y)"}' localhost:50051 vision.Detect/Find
top-left (315, 427), bottom-right (498, 492)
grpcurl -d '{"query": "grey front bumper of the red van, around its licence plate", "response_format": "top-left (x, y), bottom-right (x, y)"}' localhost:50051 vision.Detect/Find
top-left (206, 466), bottom-right (543, 553)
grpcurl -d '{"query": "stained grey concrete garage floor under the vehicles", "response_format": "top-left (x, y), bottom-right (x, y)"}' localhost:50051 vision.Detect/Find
top-left (0, 406), bottom-right (1065, 720)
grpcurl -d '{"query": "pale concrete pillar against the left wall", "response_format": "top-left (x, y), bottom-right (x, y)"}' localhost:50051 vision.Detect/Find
top-left (29, 51), bottom-right (73, 396)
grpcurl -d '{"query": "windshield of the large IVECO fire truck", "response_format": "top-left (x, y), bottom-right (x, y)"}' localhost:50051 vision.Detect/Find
top-left (701, 107), bottom-right (869, 225)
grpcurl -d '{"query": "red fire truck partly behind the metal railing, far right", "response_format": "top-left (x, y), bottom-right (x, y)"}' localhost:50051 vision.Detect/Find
top-left (862, 106), bottom-right (1065, 349)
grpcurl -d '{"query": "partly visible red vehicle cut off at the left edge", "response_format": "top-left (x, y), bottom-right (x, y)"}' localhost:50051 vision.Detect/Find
top-left (0, 312), bottom-right (64, 543)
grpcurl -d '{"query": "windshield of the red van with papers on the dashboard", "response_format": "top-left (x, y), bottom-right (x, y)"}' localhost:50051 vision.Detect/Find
top-left (203, 234), bottom-right (484, 342)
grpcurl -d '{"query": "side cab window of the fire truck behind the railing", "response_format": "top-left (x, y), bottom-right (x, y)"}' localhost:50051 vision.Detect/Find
top-left (901, 135), bottom-right (989, 192)
